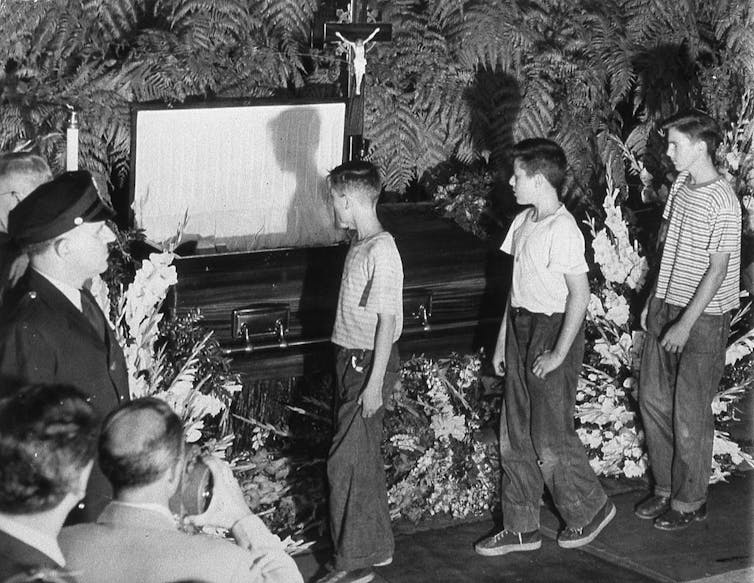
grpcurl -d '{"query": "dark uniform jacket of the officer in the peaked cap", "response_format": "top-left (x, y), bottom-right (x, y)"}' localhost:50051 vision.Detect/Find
top-left (0, 269), bottom-right (128, 522)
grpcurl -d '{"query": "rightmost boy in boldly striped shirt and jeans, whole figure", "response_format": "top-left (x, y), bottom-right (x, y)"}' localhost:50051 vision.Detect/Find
top-left (635, 112), bottom-right (741, 530)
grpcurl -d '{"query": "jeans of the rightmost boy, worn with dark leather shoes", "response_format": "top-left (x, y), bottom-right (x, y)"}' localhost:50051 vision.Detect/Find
top-left (639, 298), bottom-right (730, 512)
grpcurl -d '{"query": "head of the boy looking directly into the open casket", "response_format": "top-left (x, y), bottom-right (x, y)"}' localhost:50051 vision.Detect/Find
top-left (327, 160), bottom-right (382, 229)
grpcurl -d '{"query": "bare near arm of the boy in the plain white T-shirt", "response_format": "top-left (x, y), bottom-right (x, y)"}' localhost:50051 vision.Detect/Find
top-left (532, 273), bottom-right (589, 379)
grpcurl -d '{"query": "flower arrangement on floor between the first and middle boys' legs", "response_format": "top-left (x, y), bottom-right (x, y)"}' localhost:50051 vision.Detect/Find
top-left (383, 355), bottom-right (497, 522)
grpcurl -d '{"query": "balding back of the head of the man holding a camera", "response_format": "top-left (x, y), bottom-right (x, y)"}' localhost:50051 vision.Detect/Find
top-left (99, 397), bottom-right (184, 494)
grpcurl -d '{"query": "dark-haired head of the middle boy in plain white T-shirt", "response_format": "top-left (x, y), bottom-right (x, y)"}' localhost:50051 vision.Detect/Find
top-left (510, 138), bottom-right (568, 204)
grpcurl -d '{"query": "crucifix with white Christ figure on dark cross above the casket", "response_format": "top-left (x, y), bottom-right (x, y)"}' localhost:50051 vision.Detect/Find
top-left (324, 0), bottom-right (393, 159)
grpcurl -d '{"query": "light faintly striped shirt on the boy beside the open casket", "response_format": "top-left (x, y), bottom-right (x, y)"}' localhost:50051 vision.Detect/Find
top-left (331, 231), bottom-right (403, 350)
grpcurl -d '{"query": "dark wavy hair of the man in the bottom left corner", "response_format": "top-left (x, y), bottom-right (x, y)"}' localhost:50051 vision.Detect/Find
top-left (0, 385), bottom-right (97, 514)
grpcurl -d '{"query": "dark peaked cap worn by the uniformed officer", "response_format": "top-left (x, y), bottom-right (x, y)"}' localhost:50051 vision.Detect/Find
top-left (8, 170), bottom-right (115, 247)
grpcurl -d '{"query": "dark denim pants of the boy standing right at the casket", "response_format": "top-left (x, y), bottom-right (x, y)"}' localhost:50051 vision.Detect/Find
top-left (327, 345), bottom-right (399, 571)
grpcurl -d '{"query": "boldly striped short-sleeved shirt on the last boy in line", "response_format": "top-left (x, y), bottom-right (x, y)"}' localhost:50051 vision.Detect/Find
top-left (656, 172), bottom-right (741, 314)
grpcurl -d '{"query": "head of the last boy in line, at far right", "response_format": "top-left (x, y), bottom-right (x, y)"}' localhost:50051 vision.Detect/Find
top-left (662, 111), bottom-right (723, 172)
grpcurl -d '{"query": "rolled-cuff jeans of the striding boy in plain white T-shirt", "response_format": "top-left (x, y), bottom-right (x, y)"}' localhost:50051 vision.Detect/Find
top-left (500, 308), bottom-right (607, 532)
